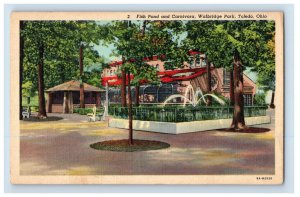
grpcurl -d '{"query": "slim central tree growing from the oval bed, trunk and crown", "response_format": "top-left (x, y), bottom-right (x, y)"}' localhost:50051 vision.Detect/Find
top-left (108, 21), bottom-right (182, 144)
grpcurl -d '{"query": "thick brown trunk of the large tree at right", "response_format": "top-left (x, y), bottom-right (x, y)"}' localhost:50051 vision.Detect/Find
top-left (231, 51), bottom-right (246, 130)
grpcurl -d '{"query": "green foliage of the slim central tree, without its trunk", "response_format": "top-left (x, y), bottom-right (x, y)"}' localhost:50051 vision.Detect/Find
top-left (106, 21), bottom-right (186, 85)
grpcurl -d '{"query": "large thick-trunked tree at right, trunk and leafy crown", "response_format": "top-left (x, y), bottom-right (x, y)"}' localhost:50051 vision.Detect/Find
top-left (187, 21), bottom-right (273, 129)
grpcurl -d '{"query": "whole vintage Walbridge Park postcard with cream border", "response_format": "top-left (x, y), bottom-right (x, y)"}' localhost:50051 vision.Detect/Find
top-left (10, 12), bottom-right (284, 184)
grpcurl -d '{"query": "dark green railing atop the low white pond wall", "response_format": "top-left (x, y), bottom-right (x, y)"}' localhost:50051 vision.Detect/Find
top-left (108, 106), bottom-right (267, 122)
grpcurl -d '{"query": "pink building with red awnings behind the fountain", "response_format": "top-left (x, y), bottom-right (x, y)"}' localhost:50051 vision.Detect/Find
top-left (101, 53), bottom-right (257, 106)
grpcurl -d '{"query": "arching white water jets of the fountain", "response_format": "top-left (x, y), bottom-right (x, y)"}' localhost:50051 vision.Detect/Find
top-left (163, 85), bottom-right (225, 107)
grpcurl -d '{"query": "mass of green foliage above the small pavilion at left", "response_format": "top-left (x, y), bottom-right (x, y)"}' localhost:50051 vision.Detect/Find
top-left (21, 21), bottom-right (104, 91)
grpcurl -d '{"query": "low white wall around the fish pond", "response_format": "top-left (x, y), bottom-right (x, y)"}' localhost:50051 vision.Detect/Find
top-left (109, 116), bottom-right (271, 134)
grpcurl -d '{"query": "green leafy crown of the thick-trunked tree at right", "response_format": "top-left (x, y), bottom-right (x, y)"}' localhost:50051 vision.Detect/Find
top-left (185, 21), bottom-right (275, 74)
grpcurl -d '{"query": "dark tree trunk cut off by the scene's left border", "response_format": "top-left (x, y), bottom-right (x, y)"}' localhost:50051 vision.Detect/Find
top-left (19, 21), bottom-right (24, 120)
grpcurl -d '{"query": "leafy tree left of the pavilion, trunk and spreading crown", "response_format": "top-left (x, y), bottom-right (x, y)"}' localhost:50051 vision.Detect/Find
top-left (21, 21), bottom-right (103, 118)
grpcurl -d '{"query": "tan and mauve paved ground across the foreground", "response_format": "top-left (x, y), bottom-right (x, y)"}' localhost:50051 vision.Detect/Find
top-left (20, 109), bottom-right (274, 175)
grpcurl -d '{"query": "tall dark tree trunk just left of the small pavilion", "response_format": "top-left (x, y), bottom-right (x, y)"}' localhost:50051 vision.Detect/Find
top-left (38, 43), bottom-right (47, 118)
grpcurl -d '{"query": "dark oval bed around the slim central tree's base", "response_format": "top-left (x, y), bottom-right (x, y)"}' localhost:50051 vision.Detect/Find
top-left (90, 139), bottom-right (170, 152)
